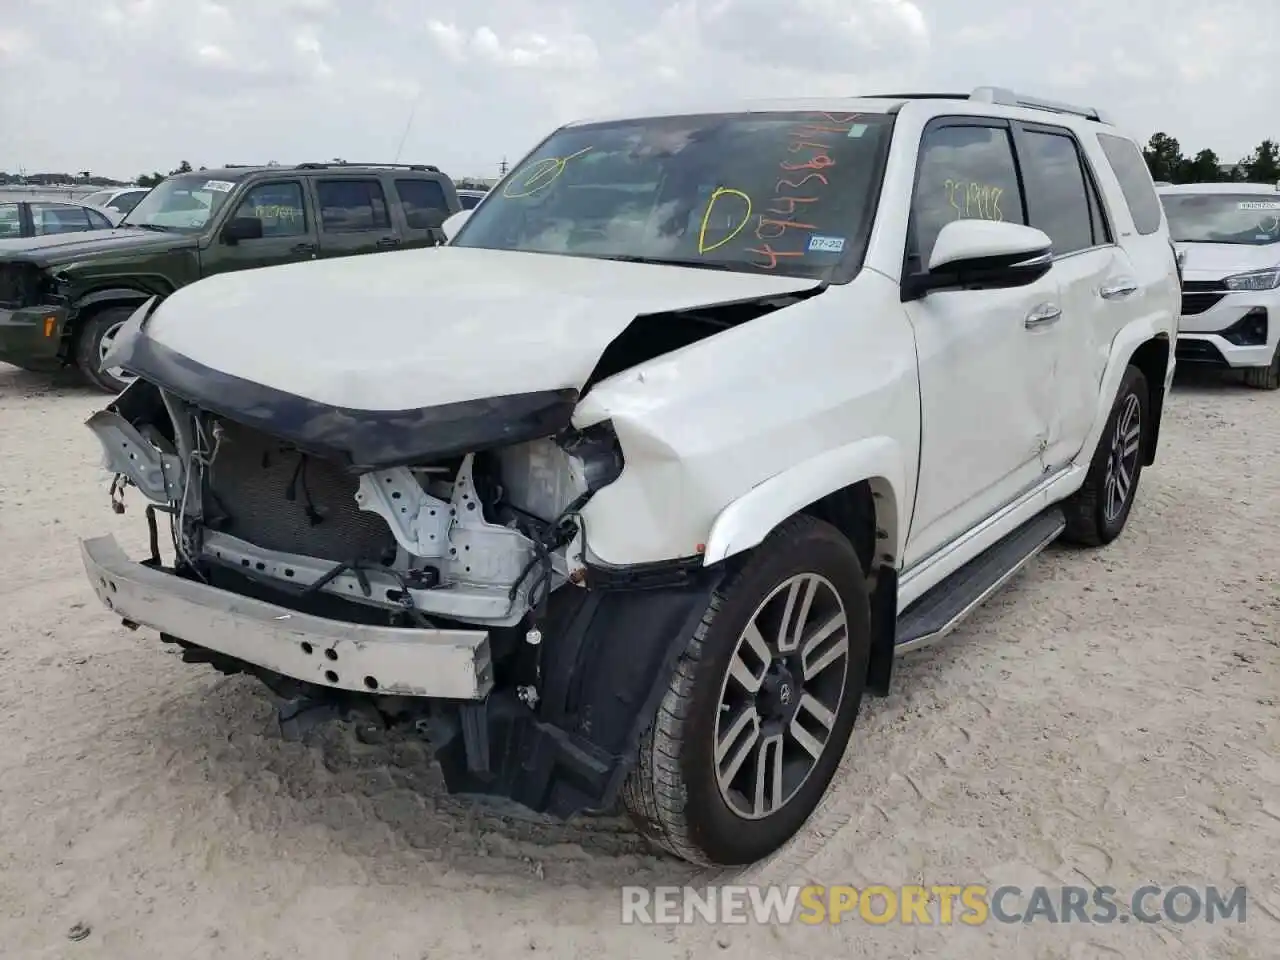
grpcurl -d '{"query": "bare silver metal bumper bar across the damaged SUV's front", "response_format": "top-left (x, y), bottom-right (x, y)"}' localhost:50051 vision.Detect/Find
top-left (81, 536), bottom-right (493, 700)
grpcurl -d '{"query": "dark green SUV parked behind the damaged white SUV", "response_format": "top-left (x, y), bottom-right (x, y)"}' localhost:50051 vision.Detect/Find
top-left (0, 163), bottom-right (461, 393)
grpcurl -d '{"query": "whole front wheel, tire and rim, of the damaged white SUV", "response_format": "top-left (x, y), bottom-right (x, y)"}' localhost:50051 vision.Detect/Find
top-left (622, 516), bottom-right (870, 867)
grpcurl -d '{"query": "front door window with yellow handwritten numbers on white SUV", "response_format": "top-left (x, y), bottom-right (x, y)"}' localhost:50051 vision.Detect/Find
top-left (910, 124), bottom-right (1027, 265)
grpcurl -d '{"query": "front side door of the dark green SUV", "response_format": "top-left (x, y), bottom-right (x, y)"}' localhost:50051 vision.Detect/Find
top-left (201, 180), bottom-right (319, 276)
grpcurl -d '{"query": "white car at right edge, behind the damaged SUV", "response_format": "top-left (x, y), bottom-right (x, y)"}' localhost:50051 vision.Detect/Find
top-left (1160, 183), bottom-right (1280, 390)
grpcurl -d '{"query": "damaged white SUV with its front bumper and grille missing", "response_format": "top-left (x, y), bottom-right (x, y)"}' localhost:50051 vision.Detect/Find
top-left (82, 88), bottom-right (1179, 865)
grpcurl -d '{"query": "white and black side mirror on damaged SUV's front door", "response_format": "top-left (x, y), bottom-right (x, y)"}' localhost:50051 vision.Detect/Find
top-left (904, 220), bottom-right (1053, 300)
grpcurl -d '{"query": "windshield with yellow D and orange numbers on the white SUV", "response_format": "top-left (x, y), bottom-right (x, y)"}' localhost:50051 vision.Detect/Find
top-left (453, 113), bottom-right (892, 279)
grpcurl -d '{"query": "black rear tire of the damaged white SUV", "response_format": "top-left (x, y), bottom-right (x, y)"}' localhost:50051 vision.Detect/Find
top-left (1062, 366), bottom-right (1151, 547)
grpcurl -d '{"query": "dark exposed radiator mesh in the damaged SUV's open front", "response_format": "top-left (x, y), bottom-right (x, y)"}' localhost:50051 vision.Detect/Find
top-left (205, 421), bottom-right (396, 563)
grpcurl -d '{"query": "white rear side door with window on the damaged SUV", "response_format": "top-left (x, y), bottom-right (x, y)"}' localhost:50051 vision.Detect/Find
top-left (1014, 123), bottom-right (1137, 470)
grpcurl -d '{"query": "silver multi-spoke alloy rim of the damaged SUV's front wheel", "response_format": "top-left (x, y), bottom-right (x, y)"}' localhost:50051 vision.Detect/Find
top-left (714, 573), bottom-right (849, 819)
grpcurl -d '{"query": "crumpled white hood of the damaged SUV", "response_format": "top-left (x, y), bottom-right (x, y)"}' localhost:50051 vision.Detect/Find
top-left (145, 246), bottom-right (817, 411)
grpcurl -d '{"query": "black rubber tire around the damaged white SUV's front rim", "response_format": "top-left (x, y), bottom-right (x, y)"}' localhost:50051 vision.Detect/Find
top-left (622, 516), bottom-right (870, 867)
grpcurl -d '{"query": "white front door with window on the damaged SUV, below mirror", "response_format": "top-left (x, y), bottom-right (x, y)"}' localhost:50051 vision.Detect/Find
top-left (904, 116), bottom-right (1061, 567)
